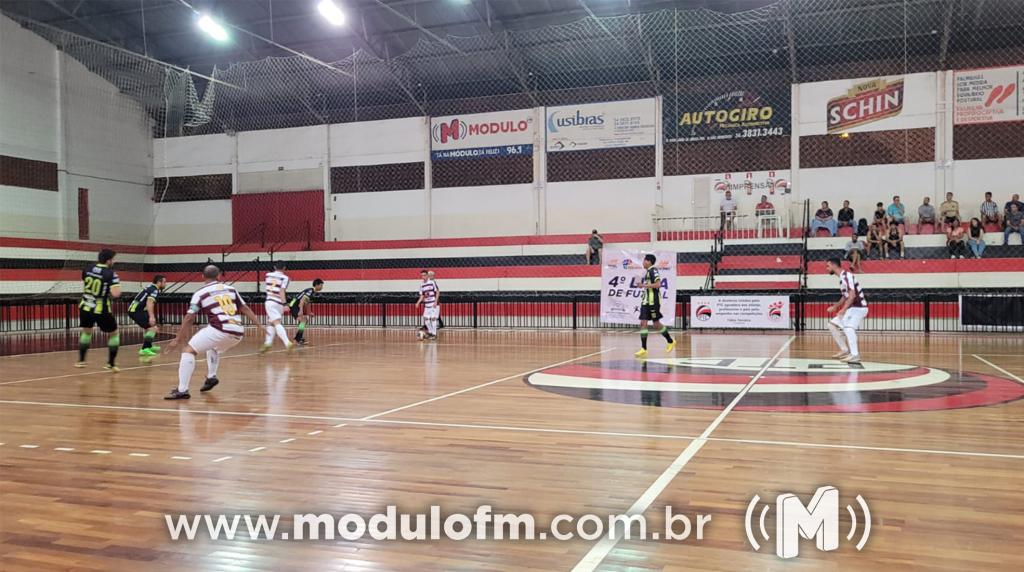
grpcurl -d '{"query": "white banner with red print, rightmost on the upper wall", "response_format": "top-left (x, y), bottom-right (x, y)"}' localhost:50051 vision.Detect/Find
top-left (953, 65), bottom-right (1024, 125)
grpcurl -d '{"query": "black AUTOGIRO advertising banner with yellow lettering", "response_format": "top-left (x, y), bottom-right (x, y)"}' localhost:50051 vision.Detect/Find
top-left (663, 86), bottom-right (791, 141)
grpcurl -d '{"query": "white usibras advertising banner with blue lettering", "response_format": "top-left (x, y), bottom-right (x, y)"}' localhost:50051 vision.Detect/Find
top-left (547, 99), bottom-right (657, 152)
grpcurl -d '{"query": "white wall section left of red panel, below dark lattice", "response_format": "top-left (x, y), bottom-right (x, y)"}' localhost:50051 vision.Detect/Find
top-left (148, 201), bottom-right (231, 247)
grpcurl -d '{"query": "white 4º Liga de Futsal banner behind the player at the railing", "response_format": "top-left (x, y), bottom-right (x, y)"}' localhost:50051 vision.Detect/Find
top-left (601, 247), bottom-right (676, 325)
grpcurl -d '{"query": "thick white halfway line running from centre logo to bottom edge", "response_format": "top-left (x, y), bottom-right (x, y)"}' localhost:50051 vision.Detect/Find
top-left (572, 336), bottom-right (797, 572)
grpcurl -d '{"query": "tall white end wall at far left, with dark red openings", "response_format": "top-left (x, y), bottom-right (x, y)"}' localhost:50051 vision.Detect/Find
top-left (0, 16), bottom-right (154, 245)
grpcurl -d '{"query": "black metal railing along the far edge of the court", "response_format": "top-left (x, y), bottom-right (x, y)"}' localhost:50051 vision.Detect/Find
top-left (0, 291), bottom-right (1024, 334)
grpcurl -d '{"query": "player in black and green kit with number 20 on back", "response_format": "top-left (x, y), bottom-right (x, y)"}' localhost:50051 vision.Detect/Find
top-left (75, 249), bottom-right (121, 373)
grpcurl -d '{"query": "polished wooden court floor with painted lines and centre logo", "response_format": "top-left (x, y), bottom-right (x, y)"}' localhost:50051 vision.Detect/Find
top-left (0, 329), bottom-right (1024, 571)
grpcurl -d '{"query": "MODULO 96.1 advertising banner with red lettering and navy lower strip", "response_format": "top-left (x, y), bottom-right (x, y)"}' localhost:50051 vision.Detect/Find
top-left (430, 109), bottom-right (535, 161)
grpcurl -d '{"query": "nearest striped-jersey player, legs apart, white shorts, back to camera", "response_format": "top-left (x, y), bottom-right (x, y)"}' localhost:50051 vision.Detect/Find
top-left (164, 264), bottom-right (259, 399)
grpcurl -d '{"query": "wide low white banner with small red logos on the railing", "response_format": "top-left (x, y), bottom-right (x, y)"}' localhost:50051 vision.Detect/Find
top-left (690, 296), bottom-right (791, 329)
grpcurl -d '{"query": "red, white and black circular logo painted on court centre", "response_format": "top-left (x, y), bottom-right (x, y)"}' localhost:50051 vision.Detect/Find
top-left (524, 357), bottom-right (1024, 413)
